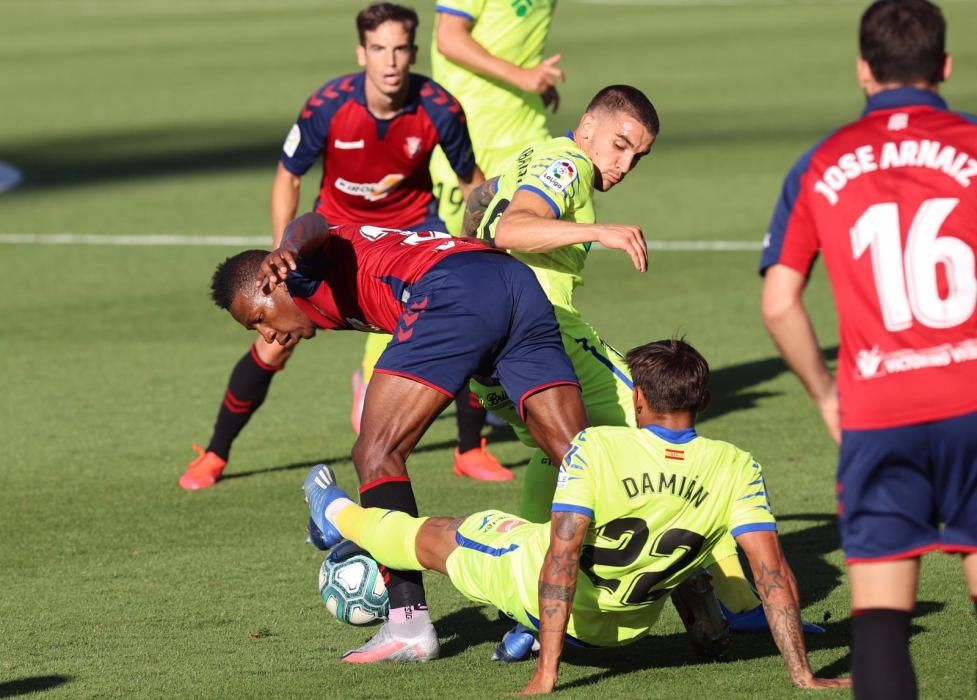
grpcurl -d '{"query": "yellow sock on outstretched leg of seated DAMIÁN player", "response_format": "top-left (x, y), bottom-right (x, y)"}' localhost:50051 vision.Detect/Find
top-left (336, 503), bottom-right (427, 571)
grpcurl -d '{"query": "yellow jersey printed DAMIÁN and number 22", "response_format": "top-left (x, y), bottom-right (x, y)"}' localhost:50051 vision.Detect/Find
top-left (533, 426), bottom-right (776, 646)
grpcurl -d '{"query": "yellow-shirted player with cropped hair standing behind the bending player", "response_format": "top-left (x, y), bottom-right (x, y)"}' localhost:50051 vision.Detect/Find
top-left (465, 85), bottom-right (792, 632)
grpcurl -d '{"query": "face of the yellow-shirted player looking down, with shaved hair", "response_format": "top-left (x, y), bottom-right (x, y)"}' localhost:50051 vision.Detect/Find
top-left (579, 112), bottom-right (655, 192)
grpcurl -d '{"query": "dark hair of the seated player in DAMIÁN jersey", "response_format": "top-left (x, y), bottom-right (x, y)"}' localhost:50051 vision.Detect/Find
top-left (627, 338), bottom-right (709, 413)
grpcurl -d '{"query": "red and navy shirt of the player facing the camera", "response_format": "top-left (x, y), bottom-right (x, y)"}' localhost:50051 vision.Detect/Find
top-left (281, 73), bottom-right (475, 227)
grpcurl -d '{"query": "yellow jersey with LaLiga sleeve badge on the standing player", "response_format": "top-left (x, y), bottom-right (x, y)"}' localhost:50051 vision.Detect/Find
top-left (478, 134), bottom-right (596, 313)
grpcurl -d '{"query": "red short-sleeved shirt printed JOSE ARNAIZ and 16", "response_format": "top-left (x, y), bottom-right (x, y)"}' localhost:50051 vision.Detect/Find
top-left (761, 88), bottom-right (977, 430)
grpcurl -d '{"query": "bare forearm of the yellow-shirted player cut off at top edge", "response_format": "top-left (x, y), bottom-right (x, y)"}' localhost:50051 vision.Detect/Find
top-left (435, 11), bottom-right (565, 109)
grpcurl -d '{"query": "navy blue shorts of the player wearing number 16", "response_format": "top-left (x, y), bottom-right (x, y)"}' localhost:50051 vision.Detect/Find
top-left (838, 413), bottom-right (977, 564)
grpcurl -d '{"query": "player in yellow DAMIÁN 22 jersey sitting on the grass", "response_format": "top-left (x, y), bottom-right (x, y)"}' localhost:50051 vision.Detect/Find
top-left (305, 339), bottom-right (848, 694)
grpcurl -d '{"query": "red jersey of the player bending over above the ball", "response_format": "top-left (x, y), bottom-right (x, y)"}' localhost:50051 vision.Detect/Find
top-left (285, 224), bottom-right (496, 334)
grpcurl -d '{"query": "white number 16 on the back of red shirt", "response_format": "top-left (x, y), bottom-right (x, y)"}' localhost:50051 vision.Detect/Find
top-left (851, 198), bottom-right (977, 331)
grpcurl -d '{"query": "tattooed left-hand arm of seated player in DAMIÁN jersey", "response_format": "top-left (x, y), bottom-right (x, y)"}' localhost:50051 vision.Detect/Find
top-left (522, 512), bottom-right (590, 695)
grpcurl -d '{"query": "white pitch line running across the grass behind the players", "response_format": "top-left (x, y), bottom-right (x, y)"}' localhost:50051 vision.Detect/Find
top-left (0, 233), bottom-right (762, 251)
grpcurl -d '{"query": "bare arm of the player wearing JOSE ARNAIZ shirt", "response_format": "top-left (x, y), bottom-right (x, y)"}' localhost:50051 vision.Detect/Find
top-left (762, 264), bottom-right (841, 442)
